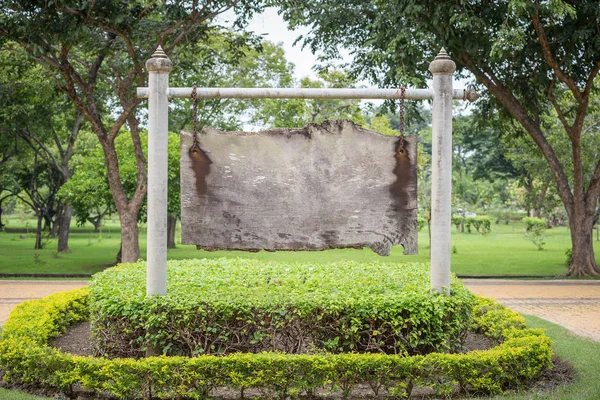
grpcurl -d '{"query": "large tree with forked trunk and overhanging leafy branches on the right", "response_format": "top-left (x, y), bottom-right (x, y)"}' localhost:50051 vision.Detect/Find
top-left (276, 0), bottom-right (600, 276)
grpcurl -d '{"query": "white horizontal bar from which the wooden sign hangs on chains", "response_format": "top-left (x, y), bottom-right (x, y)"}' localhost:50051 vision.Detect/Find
top-left (137, 87), bottom-right (479, 101)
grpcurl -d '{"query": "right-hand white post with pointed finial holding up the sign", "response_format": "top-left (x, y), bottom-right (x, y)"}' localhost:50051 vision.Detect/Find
top-left (429, 48), bottom-right (456, 295)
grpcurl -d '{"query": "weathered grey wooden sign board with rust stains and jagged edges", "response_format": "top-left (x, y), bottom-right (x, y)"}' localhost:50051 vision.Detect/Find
top-left (181, 120), bottom-right (417, 255)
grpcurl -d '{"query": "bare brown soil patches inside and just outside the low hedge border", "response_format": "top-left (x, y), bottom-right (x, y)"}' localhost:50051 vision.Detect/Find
top-left (0, 322), bottom-right (575, 400)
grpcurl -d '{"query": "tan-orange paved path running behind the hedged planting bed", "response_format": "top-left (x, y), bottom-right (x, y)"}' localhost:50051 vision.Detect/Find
top-left (0, 279), bottom-right (600, 341)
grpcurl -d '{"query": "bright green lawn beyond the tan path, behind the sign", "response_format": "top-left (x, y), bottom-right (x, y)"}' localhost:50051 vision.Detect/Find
top-left (0, 220), bottom-right (600, 275)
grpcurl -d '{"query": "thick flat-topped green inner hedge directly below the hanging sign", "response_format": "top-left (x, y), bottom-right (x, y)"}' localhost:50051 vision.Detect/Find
top-left (90, 258), bottom-right (472, 357)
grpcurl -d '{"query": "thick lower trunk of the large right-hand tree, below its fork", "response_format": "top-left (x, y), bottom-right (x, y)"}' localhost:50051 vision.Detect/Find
top-left (566, 209), bottom-right (600, 277)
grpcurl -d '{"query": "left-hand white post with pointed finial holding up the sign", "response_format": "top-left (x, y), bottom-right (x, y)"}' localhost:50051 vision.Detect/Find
top-left (146, 46), bottom-right (173, 296)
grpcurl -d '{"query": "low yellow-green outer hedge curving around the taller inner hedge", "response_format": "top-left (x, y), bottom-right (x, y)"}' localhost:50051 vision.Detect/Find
top-left (0, 288), bottom-right (552, 399)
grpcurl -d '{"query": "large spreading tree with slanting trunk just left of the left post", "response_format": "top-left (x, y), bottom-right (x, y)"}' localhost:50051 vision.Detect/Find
top-left (0, 0), bottom-right (258, 262)
